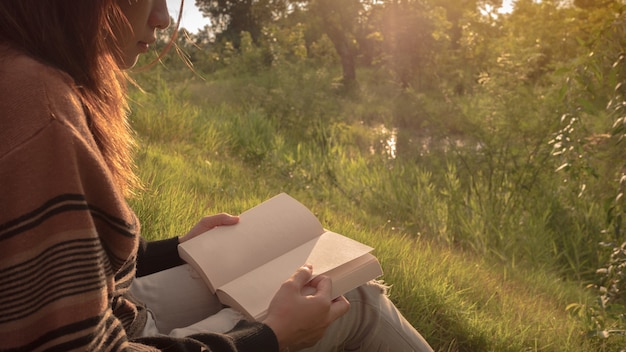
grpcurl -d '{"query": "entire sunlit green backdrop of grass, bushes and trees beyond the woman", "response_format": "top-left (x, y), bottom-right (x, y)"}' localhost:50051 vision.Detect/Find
top-left (124, 0), bottom-right (626, 352)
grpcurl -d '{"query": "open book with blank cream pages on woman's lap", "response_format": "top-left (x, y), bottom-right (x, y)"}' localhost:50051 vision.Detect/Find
top-left (178, 193), bottom-right (382, 320)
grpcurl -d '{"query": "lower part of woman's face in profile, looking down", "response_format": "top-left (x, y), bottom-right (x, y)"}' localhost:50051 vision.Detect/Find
top-left (117, 0), bottom-right (170, 68)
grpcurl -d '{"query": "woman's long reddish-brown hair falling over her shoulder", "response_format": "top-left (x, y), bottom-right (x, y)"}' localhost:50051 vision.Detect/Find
top-left (0, 0), bottom-right (182, 196)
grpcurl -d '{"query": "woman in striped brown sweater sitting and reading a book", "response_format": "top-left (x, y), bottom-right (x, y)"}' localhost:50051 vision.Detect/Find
top-left (0, 0), bottom-right (430, 351)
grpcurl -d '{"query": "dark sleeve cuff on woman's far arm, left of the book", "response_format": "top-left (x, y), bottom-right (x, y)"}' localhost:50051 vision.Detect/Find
top-left (135, 237), bottom-right (185, 277)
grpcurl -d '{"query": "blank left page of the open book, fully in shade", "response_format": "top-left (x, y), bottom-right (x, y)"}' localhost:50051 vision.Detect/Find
top-left (179, 193), bottom-right (324, 292)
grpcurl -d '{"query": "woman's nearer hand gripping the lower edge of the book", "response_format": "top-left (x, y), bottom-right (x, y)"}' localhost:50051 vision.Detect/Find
top-left (263, 265), bottom-right (350, 350)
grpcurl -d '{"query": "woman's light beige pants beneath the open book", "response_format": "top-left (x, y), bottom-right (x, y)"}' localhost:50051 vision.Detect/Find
top-left (131, 265), bottom-right (432, 352)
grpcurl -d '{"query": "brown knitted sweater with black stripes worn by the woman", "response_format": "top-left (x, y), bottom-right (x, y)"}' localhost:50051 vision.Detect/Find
top-left (0, 45), bottom-right (277, 351)
